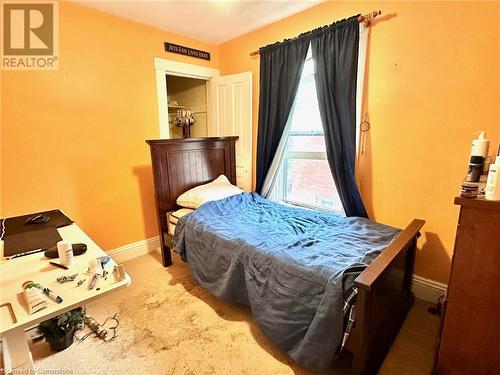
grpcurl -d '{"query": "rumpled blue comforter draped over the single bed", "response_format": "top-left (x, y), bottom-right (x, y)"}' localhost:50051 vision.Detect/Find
top-left (174, 193), bottom-right (399, 369)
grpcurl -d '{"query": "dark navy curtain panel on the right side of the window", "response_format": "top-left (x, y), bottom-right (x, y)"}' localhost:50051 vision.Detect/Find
top-left (311, 16), bottom-right (367, 217)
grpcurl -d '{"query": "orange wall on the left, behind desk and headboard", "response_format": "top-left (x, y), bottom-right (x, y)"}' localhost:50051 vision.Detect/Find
top-left (1, 3), bottom-right (219, 249)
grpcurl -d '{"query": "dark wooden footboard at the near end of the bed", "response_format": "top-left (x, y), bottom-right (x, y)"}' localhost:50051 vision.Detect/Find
top-left (347, 219), bottom-right (425, 375)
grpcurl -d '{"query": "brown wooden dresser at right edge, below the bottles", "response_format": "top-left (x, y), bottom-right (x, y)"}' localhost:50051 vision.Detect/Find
top-left (433, 197), bottom-right (500, 375)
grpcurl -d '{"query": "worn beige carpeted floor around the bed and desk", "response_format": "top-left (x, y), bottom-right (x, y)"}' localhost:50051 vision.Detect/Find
top-left (32, 253), bottom-right (439, 375)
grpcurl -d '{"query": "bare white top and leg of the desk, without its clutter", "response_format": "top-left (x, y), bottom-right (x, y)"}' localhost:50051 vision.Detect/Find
top-left (0, 224), bottom-right (131, 372)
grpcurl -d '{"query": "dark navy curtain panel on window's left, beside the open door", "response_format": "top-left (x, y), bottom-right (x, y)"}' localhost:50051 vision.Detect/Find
top-left (255, 36), bottom-right (309, 193)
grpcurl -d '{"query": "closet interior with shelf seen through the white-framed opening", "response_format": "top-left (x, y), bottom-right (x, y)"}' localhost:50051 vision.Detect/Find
top-left (166, 74), bottom-right (208, 138)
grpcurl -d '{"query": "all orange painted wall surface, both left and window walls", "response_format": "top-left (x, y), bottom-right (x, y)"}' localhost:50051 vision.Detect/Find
top-left (0, 1), bottom-right (500, 282)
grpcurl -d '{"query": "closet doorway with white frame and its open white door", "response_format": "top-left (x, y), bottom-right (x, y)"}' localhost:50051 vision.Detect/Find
top-left (154, 57), bottom-right (253, 191)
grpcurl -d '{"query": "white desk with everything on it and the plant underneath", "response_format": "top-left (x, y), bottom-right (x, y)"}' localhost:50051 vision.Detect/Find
top-left (0, 217), bottom-right (131, 373)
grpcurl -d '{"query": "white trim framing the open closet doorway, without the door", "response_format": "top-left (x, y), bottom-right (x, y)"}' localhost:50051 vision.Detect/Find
top-left (154, 57), bottom-right (220, 139)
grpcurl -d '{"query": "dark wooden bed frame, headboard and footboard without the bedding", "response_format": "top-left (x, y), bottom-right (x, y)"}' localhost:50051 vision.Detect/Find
top-left (147, 137), bottom-right (424, 374)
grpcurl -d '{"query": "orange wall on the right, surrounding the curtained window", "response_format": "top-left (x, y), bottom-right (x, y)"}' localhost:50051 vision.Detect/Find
top-left (219, 1), bottom-right (500, 282)
